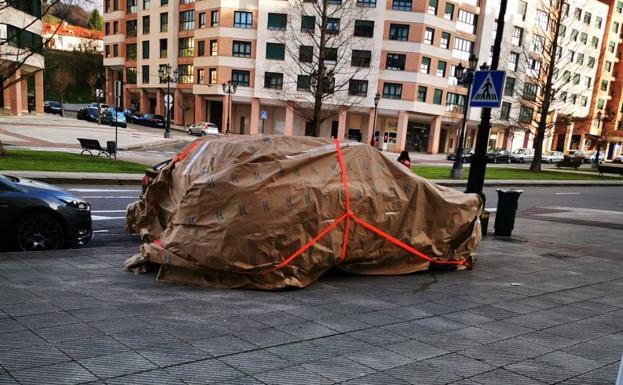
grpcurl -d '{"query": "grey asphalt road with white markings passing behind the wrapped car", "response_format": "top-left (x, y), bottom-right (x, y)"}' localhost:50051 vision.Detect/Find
top-left (64, 186), bottom-right (623, 247)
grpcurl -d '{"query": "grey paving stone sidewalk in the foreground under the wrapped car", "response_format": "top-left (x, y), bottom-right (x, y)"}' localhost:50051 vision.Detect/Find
top-left (0, 211), bottom-right (623, 385)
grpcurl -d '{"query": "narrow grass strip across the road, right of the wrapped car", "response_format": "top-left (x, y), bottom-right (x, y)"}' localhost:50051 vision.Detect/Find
top-left (411, 166), bottom-right (613, 180)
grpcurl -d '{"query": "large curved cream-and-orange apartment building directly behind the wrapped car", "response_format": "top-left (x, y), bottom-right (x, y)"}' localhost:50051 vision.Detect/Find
top-left (104, 0), bottom-right (484, 153)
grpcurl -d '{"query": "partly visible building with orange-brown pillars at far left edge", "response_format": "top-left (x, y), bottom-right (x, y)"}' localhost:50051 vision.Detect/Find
top-left (0, 0), bottom-right (44, 115)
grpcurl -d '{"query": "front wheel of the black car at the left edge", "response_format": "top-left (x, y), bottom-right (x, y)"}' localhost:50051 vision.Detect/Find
top-left (14, 213), bottom-right (65, 251)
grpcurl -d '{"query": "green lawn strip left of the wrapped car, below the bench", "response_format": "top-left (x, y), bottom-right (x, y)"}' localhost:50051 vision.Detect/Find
top-left (0, 149), bottom-right (147, 173)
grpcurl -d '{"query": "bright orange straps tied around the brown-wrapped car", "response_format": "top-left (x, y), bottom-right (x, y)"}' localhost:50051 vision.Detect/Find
top-left (152, 139), bottom-right (467, 275)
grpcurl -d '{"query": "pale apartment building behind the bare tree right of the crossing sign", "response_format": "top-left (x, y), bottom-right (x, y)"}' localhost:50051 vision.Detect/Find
top-left (478, 0), bottom-right (615, 151)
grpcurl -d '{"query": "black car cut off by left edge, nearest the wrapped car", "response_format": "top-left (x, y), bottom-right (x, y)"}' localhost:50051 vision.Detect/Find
top-left (0, 174), bottom-right (93, 251)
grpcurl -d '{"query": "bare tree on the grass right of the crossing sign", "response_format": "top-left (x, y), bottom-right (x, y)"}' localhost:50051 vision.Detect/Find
top-left (497, 0), bottom-right (599, 171)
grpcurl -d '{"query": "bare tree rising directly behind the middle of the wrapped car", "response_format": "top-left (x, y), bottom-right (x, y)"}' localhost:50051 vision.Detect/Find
top-left (274, 0), bottom-right (374, 136)
